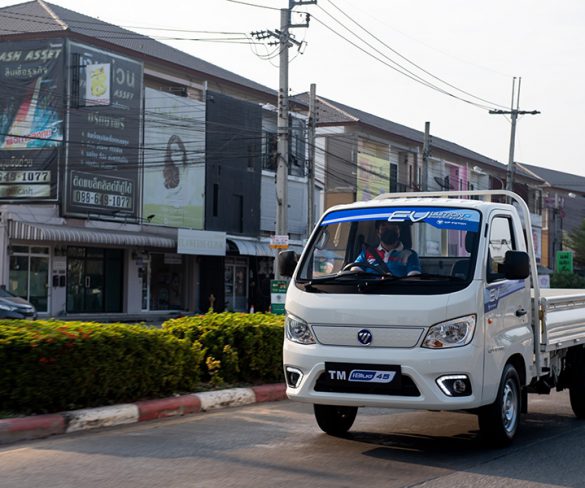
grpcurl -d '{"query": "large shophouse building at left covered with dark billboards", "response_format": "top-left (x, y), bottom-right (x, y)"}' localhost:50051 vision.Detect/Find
top-left (0, 0), bottom-right (306, 319)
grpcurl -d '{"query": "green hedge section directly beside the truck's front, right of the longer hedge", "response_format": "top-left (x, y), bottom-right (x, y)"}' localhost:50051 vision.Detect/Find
top-left (163, 312), bottom-right (284, 384)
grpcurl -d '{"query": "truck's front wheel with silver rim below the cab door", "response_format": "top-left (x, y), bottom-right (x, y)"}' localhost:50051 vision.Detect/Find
top-left (478, 364), bottom-right (522, 447)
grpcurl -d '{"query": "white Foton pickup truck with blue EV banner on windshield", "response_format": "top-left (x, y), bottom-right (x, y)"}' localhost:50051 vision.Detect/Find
top-left (279, 191), bottom-right (585, 445)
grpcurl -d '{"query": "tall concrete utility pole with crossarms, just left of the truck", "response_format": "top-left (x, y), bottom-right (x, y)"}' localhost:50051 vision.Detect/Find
top-left (252, 0), bottom-right (317, 279)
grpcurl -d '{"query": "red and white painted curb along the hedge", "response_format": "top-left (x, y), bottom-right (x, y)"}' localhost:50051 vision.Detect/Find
top-left (0, 383), bottom-right (286, 444)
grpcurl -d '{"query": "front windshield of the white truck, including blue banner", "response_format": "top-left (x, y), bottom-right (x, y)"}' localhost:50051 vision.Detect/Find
top-left (297, 206), bottom-right (481, 293)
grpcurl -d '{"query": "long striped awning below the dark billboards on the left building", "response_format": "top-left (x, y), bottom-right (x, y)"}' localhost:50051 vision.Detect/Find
top-left (8, 220), bottom-right (177, 249)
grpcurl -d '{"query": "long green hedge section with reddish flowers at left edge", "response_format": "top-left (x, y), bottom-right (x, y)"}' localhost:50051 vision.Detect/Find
top-left (0, 320), bottom-right (202, 413)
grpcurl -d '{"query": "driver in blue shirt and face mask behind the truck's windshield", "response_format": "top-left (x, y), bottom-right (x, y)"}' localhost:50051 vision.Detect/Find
top-left (352, 220), bottom-right (420, 277)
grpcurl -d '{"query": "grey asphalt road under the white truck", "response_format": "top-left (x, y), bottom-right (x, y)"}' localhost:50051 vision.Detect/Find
top-left (0, 392), bottom-right (585, 488)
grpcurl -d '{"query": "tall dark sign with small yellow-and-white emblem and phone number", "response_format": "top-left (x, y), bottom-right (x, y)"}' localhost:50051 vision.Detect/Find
top-left (65, 43), bottom-right (143, 218)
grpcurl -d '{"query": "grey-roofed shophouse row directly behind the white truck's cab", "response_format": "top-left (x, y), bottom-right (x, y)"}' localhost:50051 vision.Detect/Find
top-left (296, 94), bottom-right (545, 260)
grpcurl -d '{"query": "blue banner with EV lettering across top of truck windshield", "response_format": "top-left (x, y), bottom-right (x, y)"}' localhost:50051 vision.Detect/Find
top-left (321, 207), bottom-right (480, 232)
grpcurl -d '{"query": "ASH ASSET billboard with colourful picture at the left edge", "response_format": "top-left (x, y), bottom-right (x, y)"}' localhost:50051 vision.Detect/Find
top-left (0, 39), bottom-right (65, 201)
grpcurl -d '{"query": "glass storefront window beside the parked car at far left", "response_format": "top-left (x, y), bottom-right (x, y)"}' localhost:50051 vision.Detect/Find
top-left (8, 246), bottom-right (49, 312)
